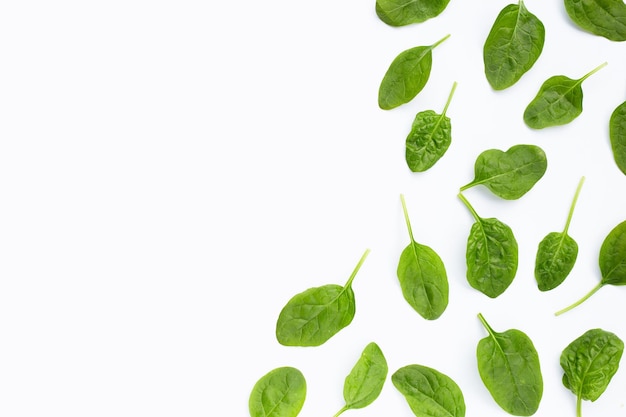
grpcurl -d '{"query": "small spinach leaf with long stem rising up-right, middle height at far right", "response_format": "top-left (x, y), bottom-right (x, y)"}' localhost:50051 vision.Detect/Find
top-left (535, 177), bottom-right (585, 291)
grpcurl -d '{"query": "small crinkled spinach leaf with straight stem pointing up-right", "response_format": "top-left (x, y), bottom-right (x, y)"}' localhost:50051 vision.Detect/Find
top-left (406, 82), bottom-right (456, 172)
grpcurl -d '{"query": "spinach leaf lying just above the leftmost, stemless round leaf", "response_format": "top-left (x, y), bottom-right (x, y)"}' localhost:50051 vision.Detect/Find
top-left (276, 249), bottom-right (369, 346)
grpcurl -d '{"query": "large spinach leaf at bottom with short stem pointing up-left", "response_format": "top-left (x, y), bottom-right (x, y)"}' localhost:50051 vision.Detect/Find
top-left (476, 314), bottom-right (543, 416)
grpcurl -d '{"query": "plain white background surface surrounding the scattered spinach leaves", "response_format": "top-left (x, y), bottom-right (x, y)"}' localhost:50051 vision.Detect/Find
top-left (0, 0), bottom-right (626, 417)
